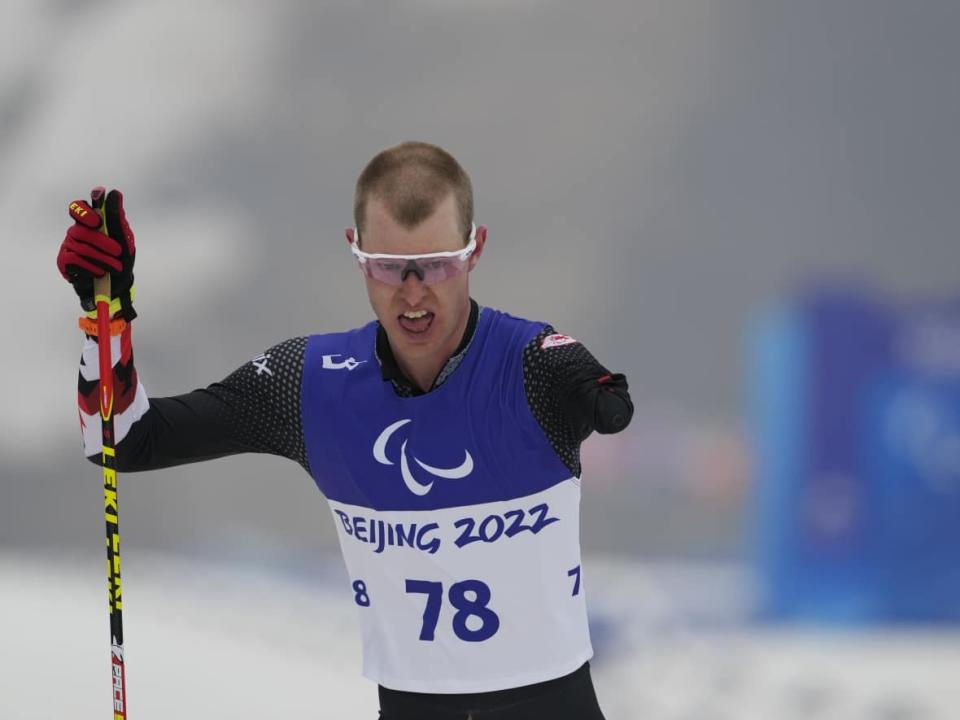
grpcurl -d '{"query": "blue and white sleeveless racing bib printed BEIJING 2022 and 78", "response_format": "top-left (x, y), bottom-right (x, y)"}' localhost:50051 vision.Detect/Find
top-left (301, 308), bottom-right (592, 693)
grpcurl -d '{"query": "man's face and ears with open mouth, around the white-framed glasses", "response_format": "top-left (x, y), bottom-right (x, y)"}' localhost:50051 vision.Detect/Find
top-left (347, 194), bottom-right (487, 380)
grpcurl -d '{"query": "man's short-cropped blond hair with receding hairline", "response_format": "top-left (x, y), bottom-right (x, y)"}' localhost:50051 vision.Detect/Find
top-left (353, 142), bottom-right (473, 244)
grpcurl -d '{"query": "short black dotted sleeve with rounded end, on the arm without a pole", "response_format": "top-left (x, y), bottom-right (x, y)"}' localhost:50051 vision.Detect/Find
top-left (523, 325), bottom-right (633, 477)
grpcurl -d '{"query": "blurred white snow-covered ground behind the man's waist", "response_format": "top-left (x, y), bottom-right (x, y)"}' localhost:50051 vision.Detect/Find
top-left (0, 550), bottom-right (960, 720)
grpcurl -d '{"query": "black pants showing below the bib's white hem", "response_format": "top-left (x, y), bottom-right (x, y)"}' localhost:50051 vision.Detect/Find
top-left (380, 663), bottom-right (604, 720)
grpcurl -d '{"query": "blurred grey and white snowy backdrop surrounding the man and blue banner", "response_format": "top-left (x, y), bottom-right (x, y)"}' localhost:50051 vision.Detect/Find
top-left (0, 0), bottom-right (960, 720)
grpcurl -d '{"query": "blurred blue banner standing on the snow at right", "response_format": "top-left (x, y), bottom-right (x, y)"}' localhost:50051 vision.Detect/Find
top-left (750, 289), bottom-right (960, 622)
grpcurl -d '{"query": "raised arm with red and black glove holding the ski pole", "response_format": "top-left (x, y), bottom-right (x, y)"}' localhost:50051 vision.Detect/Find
top-left (57, 191), bottom-right (307, 472)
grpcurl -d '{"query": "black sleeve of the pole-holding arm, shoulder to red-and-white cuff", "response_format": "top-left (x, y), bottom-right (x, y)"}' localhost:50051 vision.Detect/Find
top-left (90, 337), bottom-right (309, 472)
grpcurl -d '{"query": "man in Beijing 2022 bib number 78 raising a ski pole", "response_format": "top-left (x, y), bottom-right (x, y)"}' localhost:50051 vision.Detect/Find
top-left (58, 143), bottom-right (633, 720)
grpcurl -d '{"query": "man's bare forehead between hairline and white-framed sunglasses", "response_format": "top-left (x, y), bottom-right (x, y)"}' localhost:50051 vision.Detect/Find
top-left (361, 194), bottom-right (463, 255)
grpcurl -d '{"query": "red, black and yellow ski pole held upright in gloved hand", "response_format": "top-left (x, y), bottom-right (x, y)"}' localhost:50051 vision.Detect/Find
top-left (90, 187), bottom-right (127, 720)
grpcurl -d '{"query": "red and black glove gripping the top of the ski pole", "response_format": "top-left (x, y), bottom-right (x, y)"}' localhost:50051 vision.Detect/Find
top-left (57, 188), bottom-right (137, 322)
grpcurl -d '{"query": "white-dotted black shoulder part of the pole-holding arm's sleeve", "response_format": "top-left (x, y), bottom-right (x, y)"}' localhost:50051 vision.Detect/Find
top-left (208, 337), bottom-right (310, 472)
